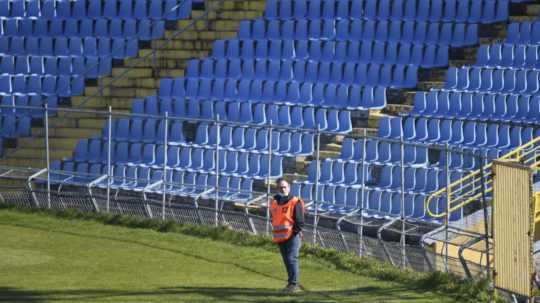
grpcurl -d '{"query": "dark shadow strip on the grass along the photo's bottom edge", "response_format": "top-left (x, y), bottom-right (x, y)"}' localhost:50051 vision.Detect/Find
top-left (0, 286), bottom-right (430, 303)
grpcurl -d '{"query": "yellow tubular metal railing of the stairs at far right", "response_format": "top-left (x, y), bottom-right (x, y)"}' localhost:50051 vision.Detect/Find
top-left (425, 137), bottom-right (540, 222)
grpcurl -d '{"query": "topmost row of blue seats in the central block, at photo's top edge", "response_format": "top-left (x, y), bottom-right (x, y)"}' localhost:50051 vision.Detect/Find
top-left (264, 0), bottom-right (508, 23)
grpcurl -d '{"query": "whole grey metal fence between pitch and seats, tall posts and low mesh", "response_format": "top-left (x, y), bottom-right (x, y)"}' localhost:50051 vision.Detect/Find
top-left (0, 104), bottom-right (496, 280)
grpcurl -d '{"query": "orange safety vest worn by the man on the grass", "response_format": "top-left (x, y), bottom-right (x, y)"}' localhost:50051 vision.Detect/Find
top-left (270, 197), bottom-right (304, 243)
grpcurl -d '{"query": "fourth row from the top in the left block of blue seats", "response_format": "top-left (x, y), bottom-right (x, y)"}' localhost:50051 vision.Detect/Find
top-left (0, 55), bottom-right (112, 78)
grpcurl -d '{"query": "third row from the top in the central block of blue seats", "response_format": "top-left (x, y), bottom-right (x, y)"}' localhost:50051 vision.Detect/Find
top-left (212, 39), bottom-right (448, 67)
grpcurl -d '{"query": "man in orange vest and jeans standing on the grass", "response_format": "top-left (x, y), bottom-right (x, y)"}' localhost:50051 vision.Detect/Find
top-left (270, 178), bottom-right (304, 293)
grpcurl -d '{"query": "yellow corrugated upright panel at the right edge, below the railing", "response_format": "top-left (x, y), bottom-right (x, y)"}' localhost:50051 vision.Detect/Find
top-left (492, 161), bottom-right (535, 297)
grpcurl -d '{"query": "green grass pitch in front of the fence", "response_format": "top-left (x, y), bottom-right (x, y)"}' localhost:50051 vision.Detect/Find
top-left (0, 209), bottom-right (451, 303)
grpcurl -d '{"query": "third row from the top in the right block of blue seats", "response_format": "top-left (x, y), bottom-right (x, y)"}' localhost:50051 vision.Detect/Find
top-left (444, 67), bottom-right (540, 94)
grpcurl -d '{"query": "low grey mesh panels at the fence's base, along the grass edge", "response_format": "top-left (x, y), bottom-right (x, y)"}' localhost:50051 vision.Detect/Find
top-left (0, 184), bottom-right (472, 275)
